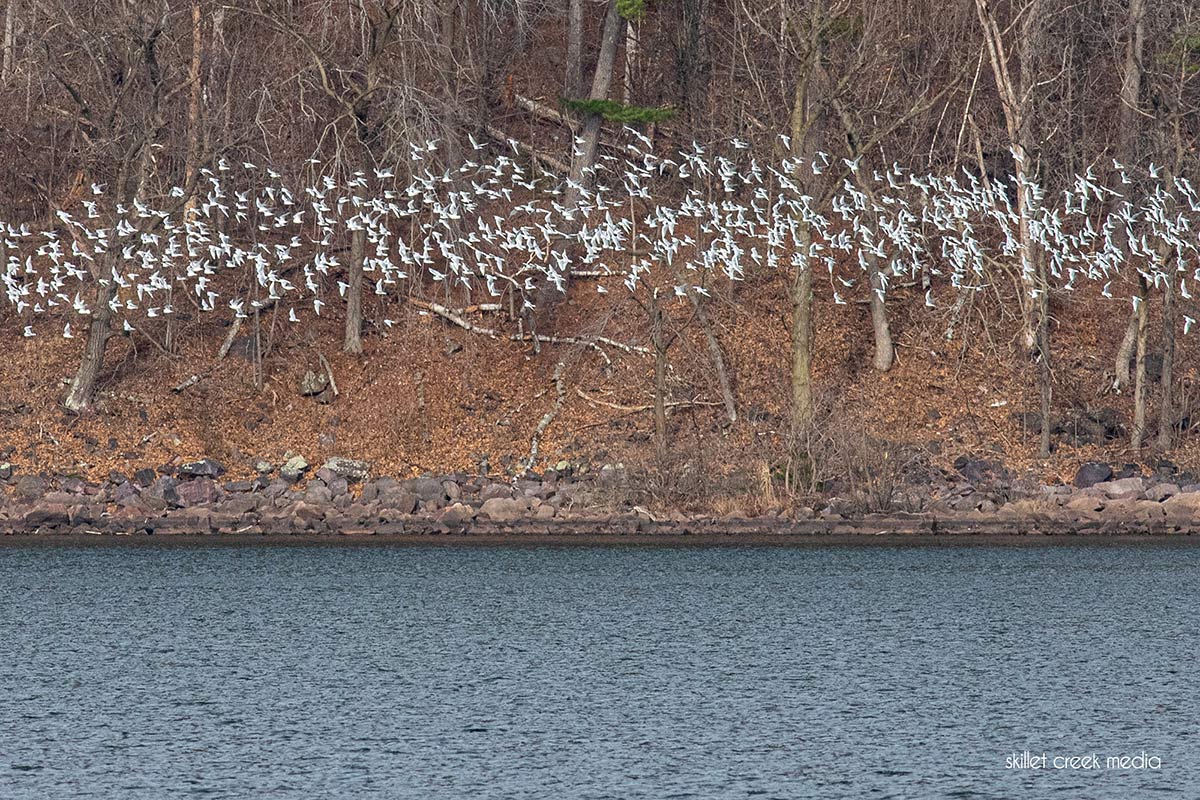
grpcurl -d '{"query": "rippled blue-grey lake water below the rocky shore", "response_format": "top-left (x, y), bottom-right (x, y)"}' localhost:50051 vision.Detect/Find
top-left (0, 542), bottom-right (1200, 800)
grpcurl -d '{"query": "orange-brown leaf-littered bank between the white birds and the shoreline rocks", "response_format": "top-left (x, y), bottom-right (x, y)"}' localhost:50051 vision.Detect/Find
top-left (0, 262), bottom-right (1195, 511)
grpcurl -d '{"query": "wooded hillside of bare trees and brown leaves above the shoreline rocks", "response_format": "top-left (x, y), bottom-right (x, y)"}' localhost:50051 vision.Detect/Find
top-left (0, 0), bottom-right (1200, 505)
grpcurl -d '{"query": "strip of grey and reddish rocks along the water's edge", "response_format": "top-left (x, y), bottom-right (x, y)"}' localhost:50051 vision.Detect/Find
top-left (0, 456), bottom-right (1200, 539)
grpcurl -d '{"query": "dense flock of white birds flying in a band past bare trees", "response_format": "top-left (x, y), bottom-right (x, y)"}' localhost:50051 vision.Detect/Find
top-left (0, 128), bottom-right (1200, 338)
